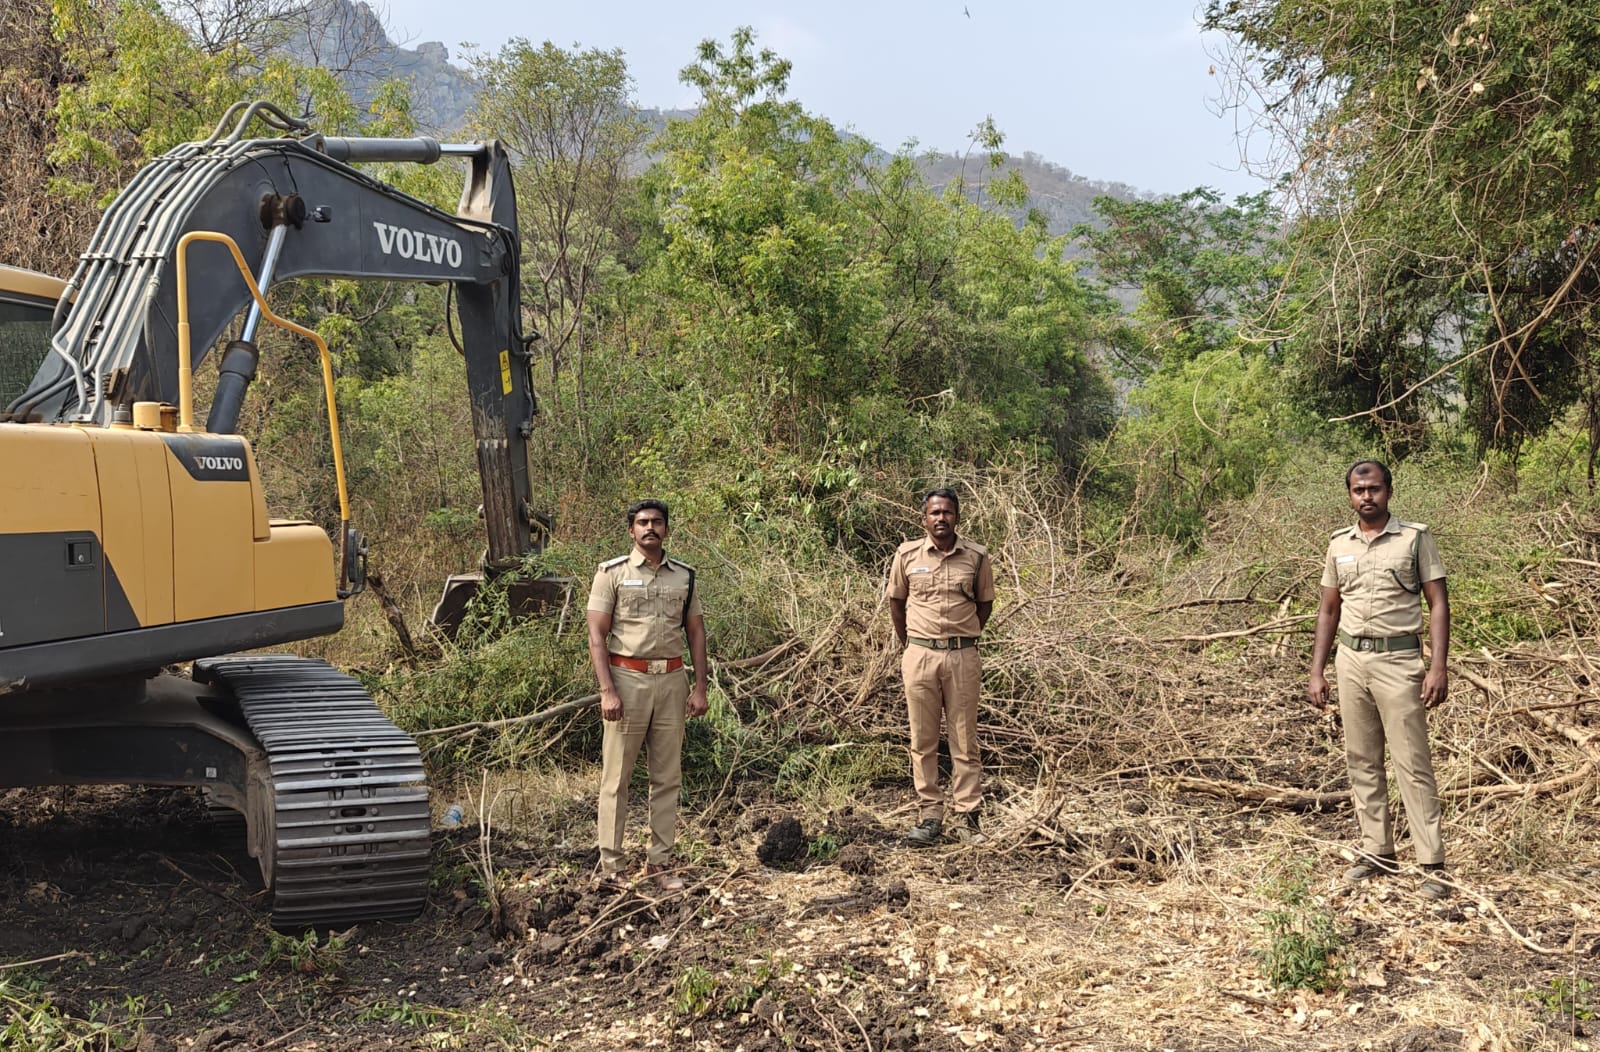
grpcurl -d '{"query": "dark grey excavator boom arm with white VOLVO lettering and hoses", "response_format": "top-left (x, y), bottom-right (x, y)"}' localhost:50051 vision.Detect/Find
top-left (6, 127), bottom-right (539, 568)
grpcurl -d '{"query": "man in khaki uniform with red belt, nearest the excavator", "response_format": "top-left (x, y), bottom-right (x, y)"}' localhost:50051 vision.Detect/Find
top-left (589, 500), bottom-right (707, 891)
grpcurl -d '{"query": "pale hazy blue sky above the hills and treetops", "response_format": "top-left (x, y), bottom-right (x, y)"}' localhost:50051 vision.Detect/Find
top-left (371, 0), bottom-right (1266, 197)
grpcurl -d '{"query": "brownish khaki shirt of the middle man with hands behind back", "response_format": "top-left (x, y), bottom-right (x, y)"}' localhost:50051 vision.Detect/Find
top-left (888, 536), bottom-right (995, 640)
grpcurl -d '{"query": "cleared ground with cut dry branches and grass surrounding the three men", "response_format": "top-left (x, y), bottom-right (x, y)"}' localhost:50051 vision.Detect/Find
top-left (0, 438), bottom-right (1600, 1049)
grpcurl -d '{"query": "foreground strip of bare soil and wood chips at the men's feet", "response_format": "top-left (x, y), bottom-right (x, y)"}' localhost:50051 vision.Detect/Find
top-left (0, 754), bottom-right (1600, 1052)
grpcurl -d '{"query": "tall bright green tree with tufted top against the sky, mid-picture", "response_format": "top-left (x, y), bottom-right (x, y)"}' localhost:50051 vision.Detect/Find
top-left (648, 29), bottom-right (878, 441)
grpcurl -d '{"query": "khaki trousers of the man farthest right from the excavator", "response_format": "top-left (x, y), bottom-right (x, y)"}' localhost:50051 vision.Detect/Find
top-left (1336, 646), bottom-right (1445, 865)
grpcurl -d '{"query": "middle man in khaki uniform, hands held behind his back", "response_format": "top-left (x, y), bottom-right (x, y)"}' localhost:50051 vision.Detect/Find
top-left (888, 489), bottom-right (995, 847)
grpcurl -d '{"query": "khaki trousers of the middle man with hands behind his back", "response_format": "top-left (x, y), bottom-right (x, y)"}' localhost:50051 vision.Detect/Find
top-left (901, 644), bottom-right (984, 820)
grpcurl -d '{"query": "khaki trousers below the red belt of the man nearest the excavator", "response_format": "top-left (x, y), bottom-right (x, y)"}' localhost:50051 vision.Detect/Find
top-left (598, 667), bottom-right (690, 873)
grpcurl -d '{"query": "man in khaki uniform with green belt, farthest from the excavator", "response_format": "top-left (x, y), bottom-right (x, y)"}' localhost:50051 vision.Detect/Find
top-left (1307, 460), bottom-right (1450, 899)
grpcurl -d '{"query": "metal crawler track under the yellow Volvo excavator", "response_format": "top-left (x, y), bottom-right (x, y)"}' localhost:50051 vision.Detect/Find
top-left (194, 654), bottom-right (430, 930)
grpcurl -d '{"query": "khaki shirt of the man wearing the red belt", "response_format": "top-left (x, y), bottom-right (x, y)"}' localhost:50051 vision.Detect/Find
top-left (589, 548), bottom-right (704, 660)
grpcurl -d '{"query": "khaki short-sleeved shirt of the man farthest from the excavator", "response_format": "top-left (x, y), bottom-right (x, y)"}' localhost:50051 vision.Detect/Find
top-left (1322, 515), bottom-right (1445, 638)
